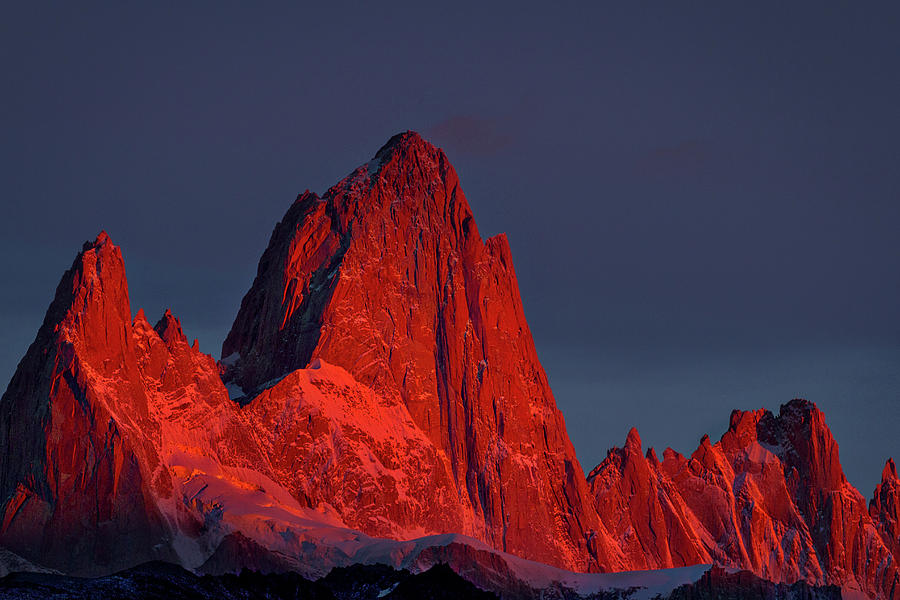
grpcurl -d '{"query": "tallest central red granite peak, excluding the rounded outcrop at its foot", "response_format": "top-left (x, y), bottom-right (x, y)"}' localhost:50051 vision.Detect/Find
top-left (222, 132), bottom-right (625, 570)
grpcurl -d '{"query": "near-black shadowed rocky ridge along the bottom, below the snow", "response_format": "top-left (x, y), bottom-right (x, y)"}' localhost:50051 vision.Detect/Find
top-left (0, 562), bottom-right (841, 600)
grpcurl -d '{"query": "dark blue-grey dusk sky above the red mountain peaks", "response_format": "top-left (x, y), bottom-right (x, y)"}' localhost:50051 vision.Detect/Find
top-left (0, 2), bottom-right (900, 496)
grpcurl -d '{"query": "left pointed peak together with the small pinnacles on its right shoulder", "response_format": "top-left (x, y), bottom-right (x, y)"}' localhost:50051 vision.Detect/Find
top-left (0, 233), bottom-right (270, 575)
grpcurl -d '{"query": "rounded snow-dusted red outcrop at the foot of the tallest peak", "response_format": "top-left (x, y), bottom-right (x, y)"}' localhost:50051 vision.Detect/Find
top-left (236, 359), bottom-right (473, 539)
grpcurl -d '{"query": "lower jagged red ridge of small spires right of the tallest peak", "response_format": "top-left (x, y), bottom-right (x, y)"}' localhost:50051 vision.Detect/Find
top-left (588, 400), bottom-right (900, 598)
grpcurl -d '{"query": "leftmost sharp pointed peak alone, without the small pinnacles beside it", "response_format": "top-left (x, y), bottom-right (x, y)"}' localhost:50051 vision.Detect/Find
top-left (0, 233), bottom-right (179, 574)
